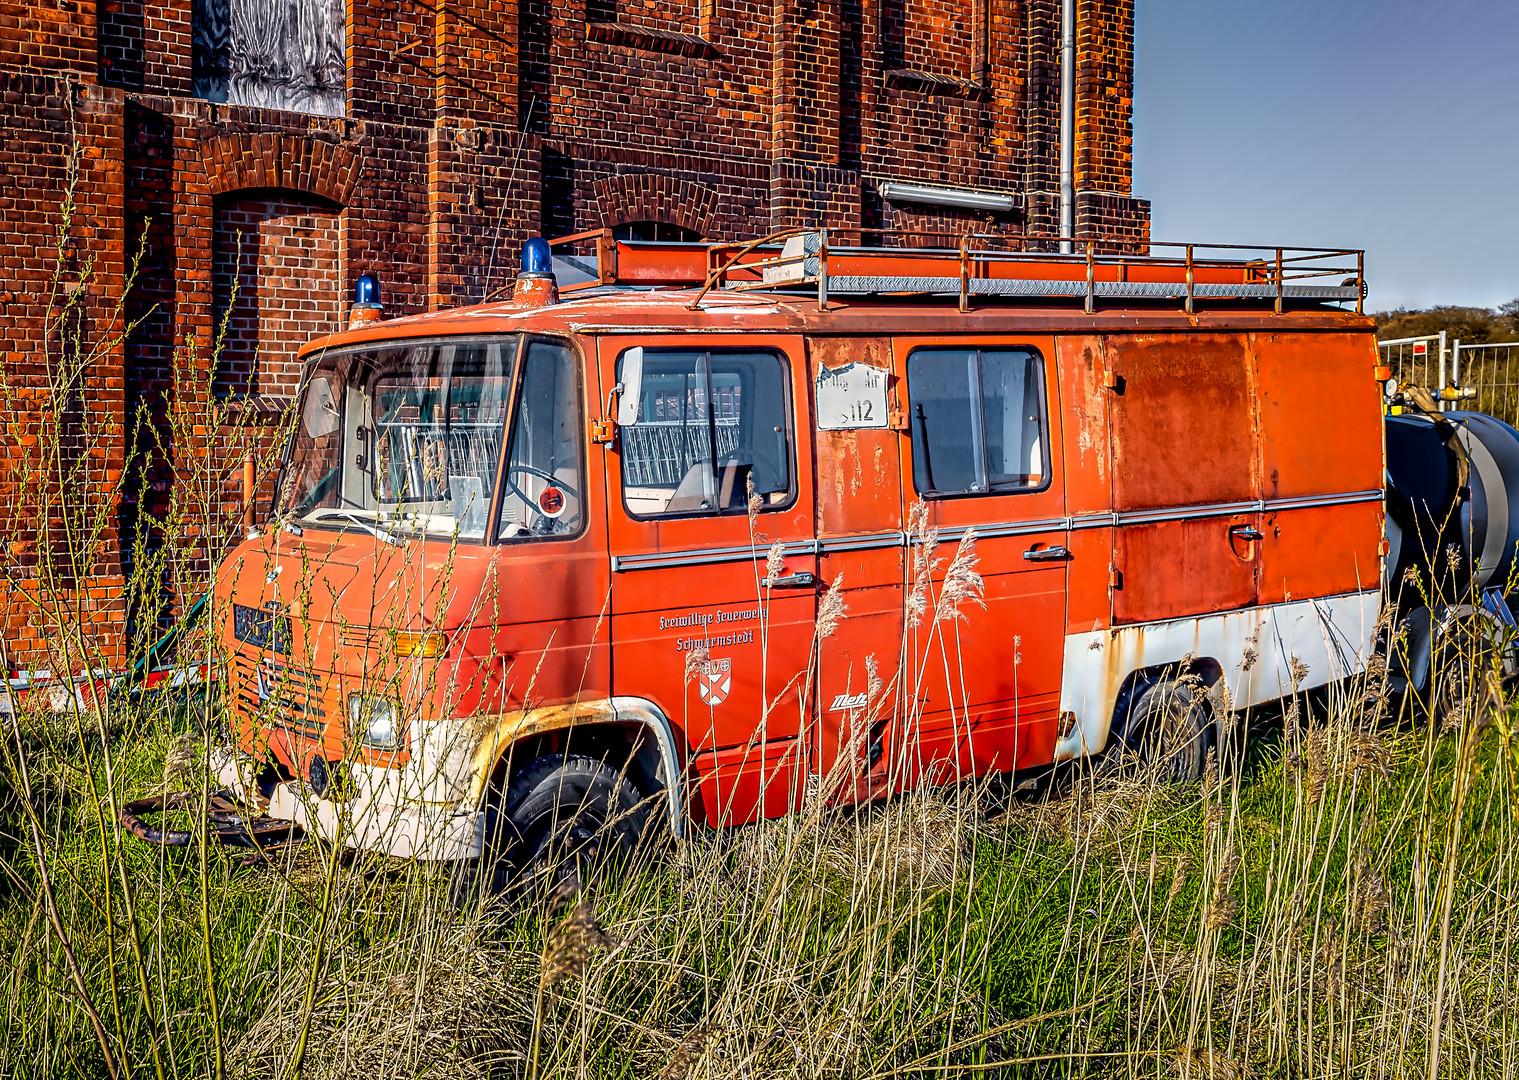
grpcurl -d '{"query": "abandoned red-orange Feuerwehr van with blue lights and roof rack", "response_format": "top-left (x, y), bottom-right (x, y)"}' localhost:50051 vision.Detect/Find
top-left (195, 231), bottom-right (1403, 887)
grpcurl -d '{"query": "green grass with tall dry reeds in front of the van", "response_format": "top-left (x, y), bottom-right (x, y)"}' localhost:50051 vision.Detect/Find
top-left (0, 662), bottom-right (1519, 1080)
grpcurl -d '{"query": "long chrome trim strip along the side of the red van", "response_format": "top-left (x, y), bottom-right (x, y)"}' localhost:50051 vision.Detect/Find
top-left (612, 488), bottom-right (1382, 574)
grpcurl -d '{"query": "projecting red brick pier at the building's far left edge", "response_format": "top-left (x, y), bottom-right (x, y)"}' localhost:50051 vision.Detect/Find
top-left (0, 75), bottom-right (125, 661)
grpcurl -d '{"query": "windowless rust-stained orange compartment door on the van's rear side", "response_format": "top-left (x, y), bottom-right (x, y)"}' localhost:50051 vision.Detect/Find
top-left (1106, 333), bottom-right (1264, 623)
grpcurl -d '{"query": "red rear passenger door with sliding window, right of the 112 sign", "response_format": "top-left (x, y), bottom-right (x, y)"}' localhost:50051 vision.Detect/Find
top-left (893, 336), bottom-right (1069, 784)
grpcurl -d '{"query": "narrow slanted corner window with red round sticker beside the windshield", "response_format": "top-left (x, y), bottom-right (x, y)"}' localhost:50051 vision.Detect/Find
top-left (497, 342), bottom-right (585, 541)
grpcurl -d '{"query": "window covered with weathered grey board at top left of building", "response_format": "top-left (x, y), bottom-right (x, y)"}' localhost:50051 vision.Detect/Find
top-left (191, 0), bottom-right (348, 117)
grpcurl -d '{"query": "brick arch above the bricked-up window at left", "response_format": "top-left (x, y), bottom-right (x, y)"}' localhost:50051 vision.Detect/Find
top-left (204, 132), bottom-right (362, 207)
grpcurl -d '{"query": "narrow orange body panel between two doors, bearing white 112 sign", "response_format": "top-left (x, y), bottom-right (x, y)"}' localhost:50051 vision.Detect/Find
top-left (807, 337), bottom-right (905, 802)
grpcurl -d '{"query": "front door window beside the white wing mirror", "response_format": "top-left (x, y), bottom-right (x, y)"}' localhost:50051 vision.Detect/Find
top-left (617, 349), bottom-right (791, 518)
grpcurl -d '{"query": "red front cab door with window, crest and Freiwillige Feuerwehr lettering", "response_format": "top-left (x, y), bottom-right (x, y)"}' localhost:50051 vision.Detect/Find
top-left (598, 334), bottom-right (817, 825)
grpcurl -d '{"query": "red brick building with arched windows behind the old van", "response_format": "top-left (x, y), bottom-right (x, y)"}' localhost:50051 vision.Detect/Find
top-left (0, 0), bottom-right (1148, 662)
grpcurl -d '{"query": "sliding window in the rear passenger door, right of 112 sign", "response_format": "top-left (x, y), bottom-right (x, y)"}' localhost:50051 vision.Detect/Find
top-left (907, 348), bottom-right (1050, 495)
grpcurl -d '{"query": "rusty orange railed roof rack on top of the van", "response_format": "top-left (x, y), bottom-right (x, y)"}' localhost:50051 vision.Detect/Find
top-left (548, 228), bottom-right (1366, 314)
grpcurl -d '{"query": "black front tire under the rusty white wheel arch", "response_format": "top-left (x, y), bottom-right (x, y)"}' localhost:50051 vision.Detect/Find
top-left (451, 755), bottom-right (649, 907)
